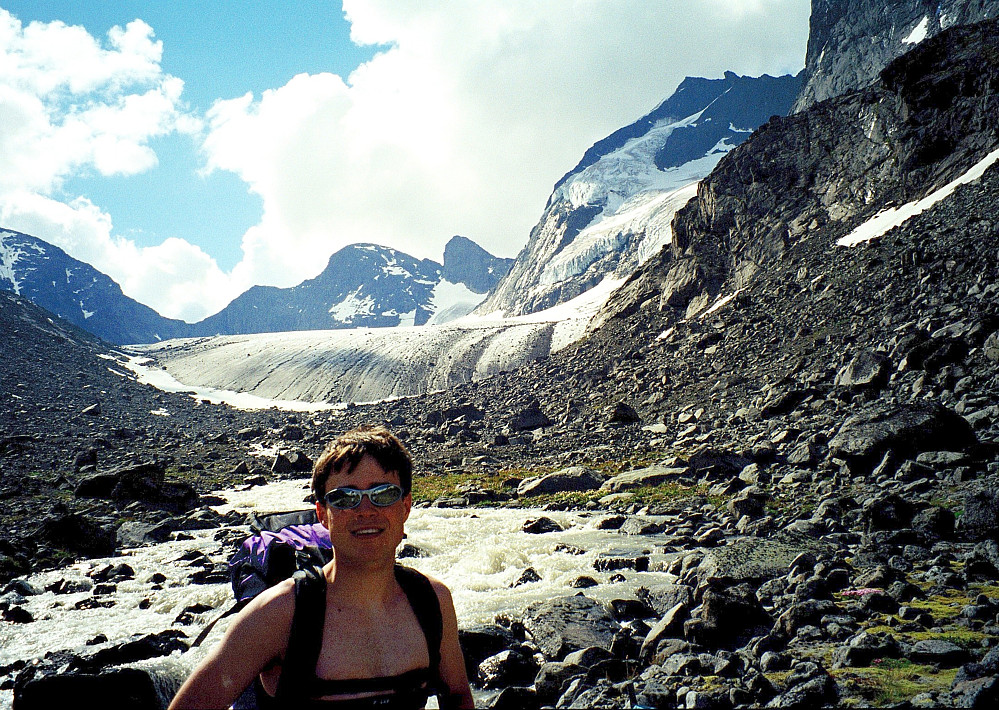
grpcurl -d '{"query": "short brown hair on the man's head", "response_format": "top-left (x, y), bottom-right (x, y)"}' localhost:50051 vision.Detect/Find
top-left (312, 424), bottom-right (413, 501)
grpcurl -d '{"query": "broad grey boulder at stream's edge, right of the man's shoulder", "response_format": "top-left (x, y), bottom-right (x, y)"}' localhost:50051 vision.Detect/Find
top-left (523, 595), bottom-right (618, 660)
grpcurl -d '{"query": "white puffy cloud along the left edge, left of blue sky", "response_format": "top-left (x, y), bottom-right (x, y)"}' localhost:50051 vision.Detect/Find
top-left (0, 9), bottom-right (229, 319)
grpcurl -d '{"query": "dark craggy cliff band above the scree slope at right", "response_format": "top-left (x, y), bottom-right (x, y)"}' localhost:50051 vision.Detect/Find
top-left (594, 20), bottom-right (999, 325)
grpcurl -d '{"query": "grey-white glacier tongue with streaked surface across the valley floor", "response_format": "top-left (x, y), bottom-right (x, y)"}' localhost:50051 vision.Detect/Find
top-left (125, 278), bottom-right (623, 408)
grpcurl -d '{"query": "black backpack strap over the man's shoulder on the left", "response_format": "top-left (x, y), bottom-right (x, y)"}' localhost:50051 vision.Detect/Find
top-left (276, 564), bottom-right (326, 700)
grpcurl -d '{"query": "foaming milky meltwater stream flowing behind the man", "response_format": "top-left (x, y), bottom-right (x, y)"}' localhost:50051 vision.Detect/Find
top-left (0, 481), bottom-right (670, 710)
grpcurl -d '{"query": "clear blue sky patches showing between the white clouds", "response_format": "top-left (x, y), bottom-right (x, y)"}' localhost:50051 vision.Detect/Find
top-left (0, 0), bottom-right (379, 270)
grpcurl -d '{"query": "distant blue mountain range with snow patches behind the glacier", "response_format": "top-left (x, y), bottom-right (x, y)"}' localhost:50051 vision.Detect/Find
top-left (0, 230), bottom-right (512, 344)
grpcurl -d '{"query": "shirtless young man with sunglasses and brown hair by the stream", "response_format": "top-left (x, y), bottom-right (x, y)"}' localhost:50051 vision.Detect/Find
top-left (170, 427), bottom-right (474, 710)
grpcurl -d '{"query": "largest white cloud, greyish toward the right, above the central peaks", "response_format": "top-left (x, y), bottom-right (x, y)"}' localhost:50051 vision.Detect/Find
top-left (205, 0), bottom-right (808, 294)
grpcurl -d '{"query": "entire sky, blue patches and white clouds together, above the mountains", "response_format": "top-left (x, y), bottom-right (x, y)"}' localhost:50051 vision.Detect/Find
top-left (0, 0), bottom-right (809, 320)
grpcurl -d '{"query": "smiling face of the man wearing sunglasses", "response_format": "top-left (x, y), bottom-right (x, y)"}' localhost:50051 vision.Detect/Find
top-left (316, 456), bottom-right (413, 565)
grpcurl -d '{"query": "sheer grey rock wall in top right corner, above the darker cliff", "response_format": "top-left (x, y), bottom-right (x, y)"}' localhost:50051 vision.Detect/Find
top-left (792, 0), bottom-right (999, 113)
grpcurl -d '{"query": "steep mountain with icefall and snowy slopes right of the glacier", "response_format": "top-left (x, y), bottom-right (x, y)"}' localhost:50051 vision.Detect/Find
top-left (476, 72), bottom-right (799, 316)
